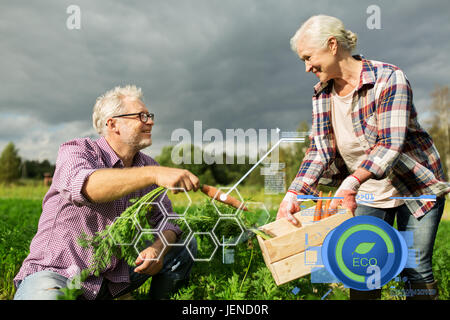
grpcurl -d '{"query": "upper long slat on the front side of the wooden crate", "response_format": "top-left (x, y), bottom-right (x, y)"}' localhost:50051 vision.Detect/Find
top-left (261, 212), bottom-right (353, 263)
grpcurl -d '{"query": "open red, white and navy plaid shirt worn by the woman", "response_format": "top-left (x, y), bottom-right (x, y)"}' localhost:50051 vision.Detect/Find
top-left (289, 56), bottom-right (450, 218)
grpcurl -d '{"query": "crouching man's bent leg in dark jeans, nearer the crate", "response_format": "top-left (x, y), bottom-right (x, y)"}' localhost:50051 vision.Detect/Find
top-left (150, 237), bottom-right (197, 300)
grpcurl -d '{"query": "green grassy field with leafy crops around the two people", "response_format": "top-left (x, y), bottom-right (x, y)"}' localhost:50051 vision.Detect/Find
top-left (0, 183), bottom-right (450, 300)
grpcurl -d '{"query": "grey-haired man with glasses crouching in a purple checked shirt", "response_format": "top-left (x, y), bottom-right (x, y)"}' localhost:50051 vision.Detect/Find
top-left (14, 86), bottom-right (199, 300)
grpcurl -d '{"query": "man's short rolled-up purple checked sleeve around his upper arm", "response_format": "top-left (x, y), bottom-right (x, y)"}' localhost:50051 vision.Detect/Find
top-left (53, 140), bottom-right (98, 207)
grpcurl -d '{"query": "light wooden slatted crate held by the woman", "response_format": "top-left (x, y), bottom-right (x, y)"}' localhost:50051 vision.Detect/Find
top-left (257, 207), bottom-right (353, 285)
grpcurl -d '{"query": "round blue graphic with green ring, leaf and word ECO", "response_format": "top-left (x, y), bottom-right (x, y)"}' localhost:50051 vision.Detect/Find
top-left (322, 216), bottom-right (408, 291)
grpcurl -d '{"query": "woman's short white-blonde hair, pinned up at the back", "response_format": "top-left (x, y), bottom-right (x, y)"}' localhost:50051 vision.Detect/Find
top-left (290, 15), bottom-right (358, 53)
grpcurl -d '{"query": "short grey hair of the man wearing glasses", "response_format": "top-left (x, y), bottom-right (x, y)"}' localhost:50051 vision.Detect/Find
top-left (92, 85), bottom-right (143, 136)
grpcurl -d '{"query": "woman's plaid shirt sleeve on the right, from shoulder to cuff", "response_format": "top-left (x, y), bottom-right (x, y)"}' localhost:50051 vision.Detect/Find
top-left (360, 70), bottom-right (412, 179)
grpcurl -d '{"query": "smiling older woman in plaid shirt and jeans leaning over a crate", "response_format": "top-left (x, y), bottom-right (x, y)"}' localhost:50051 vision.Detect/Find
top-left (277, 15), bottom-right (450, 299)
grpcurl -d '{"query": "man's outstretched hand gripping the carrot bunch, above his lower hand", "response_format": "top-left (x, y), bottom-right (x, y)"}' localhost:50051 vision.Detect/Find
top-left (151, 166), bottom-right (200, 193)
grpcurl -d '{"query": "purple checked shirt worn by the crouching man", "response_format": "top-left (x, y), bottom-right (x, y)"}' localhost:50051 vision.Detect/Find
top-left (14, 137), bottom-right (181, 299)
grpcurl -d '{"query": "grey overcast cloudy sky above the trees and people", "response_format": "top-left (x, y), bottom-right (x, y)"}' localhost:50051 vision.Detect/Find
top-left (0, 0), bottom-right (450, 162)
